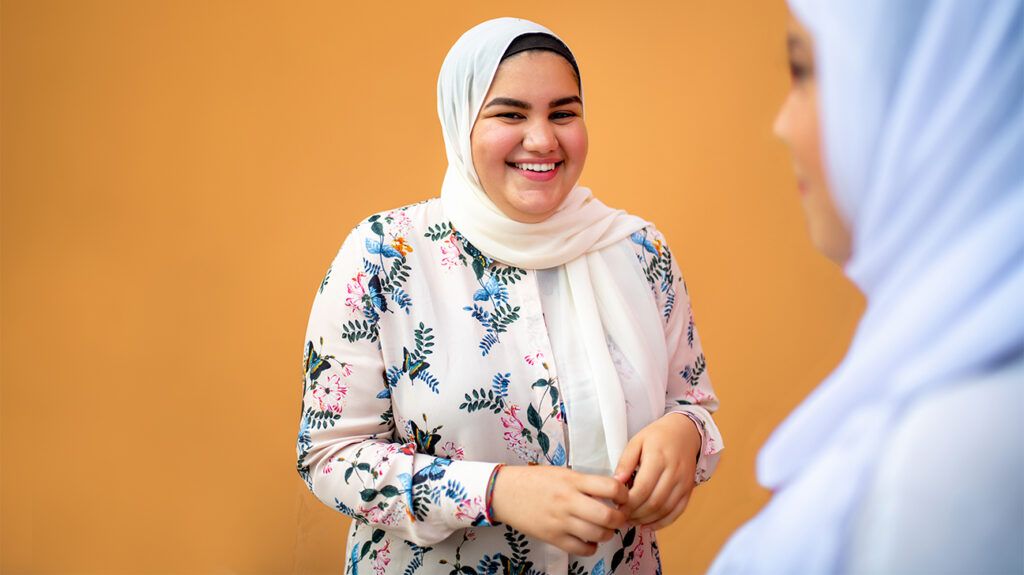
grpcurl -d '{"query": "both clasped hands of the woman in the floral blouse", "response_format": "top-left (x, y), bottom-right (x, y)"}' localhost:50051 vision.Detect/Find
top-left (492, 414), bottom-right (700, 556)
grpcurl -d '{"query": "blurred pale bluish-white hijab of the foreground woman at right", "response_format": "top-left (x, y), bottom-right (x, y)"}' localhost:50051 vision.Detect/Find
top-left (712, 0), bottom-right (1024, 573)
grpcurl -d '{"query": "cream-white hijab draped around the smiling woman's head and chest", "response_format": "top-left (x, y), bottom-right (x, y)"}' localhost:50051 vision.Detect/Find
top-left (437, 17), bottom-right (668, 473)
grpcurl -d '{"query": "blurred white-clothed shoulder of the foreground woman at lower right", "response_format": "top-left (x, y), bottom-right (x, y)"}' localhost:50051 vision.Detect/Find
top-left (850, 360), bottom-right (1024, 572)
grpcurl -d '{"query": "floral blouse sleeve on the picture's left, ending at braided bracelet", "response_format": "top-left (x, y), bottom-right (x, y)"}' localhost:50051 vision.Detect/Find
top-left (297, 219), bottom-right (496, 546)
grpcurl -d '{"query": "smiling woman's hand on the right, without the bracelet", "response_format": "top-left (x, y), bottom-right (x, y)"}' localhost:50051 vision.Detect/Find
top-left (614, 413), bottom-right (700, 530)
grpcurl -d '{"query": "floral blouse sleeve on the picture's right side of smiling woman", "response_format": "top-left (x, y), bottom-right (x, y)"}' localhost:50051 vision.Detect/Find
top-left (632, 226), bottom-right (725, 483)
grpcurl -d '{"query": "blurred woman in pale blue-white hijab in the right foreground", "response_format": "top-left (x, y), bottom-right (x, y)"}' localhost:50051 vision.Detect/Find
top-left (712, 0), bottom-right (1024, 573)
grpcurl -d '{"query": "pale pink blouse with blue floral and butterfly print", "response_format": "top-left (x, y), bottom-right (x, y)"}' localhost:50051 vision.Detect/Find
top-left (297, 198), bottom-right (722, 575)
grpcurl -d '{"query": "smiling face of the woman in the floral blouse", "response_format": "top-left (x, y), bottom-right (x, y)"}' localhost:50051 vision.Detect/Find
top-left (470, 50), bottom-right (587, 223)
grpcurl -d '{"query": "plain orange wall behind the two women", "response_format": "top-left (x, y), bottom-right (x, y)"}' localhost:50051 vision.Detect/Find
top-left (0, 0), bottom-right (862, 574)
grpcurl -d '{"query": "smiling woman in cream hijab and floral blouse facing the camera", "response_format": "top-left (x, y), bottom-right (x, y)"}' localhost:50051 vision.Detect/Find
top-left (298, 18), bottom-right (723, 575)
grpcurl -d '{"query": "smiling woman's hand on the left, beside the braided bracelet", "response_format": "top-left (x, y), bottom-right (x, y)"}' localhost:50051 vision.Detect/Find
top-left (490, 466), bottom-right (629, 556)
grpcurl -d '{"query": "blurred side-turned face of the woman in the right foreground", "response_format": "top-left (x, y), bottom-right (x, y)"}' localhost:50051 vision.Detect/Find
top-left (774, 16), bottom-right (852, 265)
